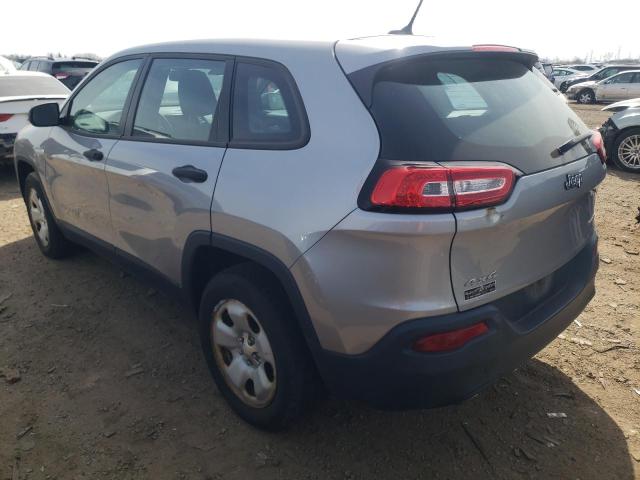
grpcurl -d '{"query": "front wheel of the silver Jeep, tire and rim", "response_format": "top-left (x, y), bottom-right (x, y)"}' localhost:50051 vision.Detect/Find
top-left (24, 173), bottom-right (73, 259)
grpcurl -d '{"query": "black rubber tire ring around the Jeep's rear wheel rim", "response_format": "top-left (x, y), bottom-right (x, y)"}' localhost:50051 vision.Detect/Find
top-left (198, 273), bottom-right (310, 430)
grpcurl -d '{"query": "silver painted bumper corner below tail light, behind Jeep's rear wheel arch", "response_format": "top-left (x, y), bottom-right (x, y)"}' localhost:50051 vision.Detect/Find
top-left (291, 210), bottom-right (457, 355)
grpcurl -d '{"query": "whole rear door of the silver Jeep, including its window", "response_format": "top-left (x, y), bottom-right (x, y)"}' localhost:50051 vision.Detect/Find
top-left (106, 55), bottom-right (232, 284)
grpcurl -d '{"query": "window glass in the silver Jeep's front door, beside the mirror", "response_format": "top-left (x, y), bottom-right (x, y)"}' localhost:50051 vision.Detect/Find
top-left (68, 59), bottom-right (142, 135)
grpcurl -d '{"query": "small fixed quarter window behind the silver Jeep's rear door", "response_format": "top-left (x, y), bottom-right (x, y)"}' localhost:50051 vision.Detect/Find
top-left (231, 61), bottom-right (309, 149)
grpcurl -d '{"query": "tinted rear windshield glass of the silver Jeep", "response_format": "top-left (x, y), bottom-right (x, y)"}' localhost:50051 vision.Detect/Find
top-left (356, 58), bottom-right (587, 173)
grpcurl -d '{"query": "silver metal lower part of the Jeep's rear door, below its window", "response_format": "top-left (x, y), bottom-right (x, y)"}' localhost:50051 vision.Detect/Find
top-left (106, 139), bottom-right (225, 285)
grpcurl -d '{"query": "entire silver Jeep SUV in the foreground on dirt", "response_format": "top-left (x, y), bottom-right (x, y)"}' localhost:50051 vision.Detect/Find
top-left (16, 35), bottom-right (606, 429)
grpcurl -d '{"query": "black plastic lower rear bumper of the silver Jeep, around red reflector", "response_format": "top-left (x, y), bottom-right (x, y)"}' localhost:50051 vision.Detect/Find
top-left (319, 234), bottom-right (598, 409)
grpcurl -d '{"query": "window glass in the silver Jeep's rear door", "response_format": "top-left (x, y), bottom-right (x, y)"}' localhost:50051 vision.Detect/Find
top-left (133, 59), bottom-right (225, 142)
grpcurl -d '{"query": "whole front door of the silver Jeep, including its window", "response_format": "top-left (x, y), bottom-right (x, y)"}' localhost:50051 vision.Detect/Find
top-left (44, 59), bottom-right (142, 243)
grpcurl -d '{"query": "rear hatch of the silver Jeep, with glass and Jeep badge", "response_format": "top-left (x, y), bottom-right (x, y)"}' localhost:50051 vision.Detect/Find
top-left (340, 49), bottom-right (605, 310)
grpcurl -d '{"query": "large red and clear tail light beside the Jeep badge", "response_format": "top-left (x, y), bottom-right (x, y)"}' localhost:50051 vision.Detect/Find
top-left (371, 166), bottom-right (515, 211)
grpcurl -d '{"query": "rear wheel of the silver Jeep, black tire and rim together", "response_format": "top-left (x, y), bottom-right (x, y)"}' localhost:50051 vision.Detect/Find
top-left (199, 263), bottom-right (320, 431)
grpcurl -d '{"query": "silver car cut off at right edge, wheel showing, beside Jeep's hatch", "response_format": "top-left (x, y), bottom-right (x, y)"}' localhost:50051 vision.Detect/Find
top-left (600, 103), bottom-right (640, 173)
